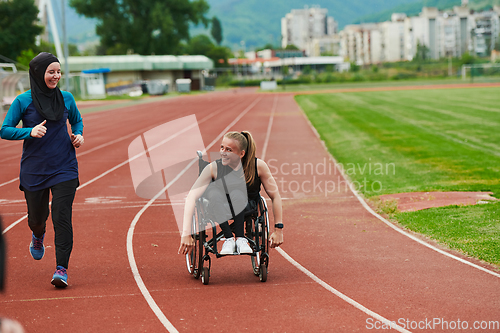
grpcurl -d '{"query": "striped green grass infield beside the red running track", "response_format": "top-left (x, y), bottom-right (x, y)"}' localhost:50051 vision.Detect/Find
top-left (296, 88), bottom-right (500, 264)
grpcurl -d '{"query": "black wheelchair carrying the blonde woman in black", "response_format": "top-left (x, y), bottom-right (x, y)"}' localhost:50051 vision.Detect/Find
top-left (186, 151), bottom-right (269, 285)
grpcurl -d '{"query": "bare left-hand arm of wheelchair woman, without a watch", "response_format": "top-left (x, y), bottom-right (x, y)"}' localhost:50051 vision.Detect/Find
top-left (178, 162), bottom-right (217, 254)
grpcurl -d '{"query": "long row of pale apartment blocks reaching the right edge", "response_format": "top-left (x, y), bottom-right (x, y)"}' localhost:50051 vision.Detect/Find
top-left (339, 1), bottom-right (500, 65)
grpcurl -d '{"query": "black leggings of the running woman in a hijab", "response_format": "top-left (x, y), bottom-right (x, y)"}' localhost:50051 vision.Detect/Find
top-left (21, 178), bottom-right (79, 268)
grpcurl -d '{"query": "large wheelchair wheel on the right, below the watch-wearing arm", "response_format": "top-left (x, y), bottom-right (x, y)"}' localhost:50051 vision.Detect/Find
top-left (250, 198), bottom-right (269, 282)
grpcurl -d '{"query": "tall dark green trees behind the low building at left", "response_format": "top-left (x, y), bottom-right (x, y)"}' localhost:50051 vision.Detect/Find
top-left (0, 0), bottom-right (232, 66)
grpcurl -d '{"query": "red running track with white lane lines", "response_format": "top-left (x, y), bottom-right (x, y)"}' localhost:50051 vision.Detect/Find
top-left (0, 89), bottom-right (500, 332)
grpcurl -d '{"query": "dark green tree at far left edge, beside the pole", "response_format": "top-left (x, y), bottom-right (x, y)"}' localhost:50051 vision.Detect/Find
top-left (0, 0), bottom-right (43, 59)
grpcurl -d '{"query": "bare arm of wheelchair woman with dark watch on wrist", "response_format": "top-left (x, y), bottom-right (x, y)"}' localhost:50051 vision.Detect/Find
top-left (257, 159), bottom-right (283, 248)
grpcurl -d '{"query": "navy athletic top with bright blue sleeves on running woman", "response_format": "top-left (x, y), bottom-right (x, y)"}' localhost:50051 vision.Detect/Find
top-left (0, 90), bottom-right (83, 191)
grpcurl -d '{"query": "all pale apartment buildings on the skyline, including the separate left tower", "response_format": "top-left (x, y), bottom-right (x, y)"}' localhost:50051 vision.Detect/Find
top-left (281, 0), bottom-right (500, 65)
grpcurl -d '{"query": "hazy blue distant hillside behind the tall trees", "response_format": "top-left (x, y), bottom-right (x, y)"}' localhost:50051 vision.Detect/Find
top-left (62, 0), bottom-right (414, 49)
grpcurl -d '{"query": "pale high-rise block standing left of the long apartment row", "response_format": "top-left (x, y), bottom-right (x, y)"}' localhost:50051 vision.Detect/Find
top-left (281, 6), bottom-right (337, 56)
